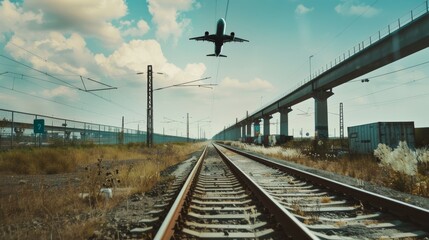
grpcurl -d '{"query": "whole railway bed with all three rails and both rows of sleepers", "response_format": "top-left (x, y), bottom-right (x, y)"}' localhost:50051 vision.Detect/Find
top-left (155, 145), bottom-right (429, 240)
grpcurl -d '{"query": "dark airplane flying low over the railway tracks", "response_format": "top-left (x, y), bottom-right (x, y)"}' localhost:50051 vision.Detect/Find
top-left (189, 18), bottom-right (249, 57)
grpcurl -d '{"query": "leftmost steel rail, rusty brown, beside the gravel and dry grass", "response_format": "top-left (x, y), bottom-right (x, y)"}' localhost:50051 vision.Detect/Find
top-left (154, 146), bottom-right (207, 240)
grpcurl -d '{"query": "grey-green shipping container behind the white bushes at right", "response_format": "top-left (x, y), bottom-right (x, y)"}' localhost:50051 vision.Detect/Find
top-left (347, 122), bottom-right (415, 153)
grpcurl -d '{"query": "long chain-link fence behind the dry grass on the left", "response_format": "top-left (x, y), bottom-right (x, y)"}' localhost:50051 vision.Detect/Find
top-left (0, 109), bottom-right (187, 148)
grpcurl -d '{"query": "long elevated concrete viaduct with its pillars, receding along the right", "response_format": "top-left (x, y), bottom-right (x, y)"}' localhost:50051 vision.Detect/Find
top-left (213, 7), bottom-right (429, 144)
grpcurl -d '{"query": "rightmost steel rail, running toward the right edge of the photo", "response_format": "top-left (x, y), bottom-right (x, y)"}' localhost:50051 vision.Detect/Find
top-left (221, 145), bottom-right (429, 229)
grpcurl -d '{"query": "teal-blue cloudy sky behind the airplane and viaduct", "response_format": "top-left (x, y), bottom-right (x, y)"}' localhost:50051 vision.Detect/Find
top-left (0, 0), bottom-right (429, 138)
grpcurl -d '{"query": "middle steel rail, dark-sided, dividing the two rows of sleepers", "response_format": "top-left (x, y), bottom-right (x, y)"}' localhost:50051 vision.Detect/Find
top-left (213, 144), bottom-right (319, 239)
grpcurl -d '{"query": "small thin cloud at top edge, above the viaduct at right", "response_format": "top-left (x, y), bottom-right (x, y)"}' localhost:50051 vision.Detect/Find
top-left (335, 0), bottom-right (380, 18)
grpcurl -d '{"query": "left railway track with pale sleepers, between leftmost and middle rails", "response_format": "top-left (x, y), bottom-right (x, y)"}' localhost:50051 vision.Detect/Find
top-left (155, 143), bottom-right (311, 239)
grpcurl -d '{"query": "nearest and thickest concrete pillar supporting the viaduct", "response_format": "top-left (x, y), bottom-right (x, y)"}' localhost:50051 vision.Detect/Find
top-left (314, 89), bottom-right (334, 139)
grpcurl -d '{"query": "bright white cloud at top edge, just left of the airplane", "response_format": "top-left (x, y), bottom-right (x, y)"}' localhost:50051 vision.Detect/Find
top-left (148, 0), bottom-right (194, 41)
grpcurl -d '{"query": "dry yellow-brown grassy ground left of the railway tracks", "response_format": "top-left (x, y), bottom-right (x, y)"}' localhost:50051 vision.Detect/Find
top-left (0, 144), bottom-right (202, 239)
